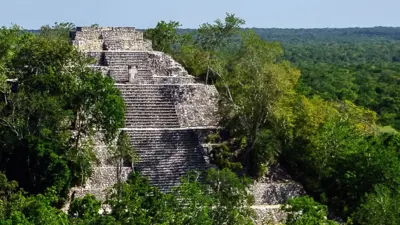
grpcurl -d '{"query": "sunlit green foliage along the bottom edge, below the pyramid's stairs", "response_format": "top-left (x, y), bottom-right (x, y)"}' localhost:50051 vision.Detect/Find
top-left (0, 169), bottom-right (254, 225)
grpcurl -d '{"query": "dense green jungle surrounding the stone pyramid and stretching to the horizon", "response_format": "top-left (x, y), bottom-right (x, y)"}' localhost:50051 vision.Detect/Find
top-left (0, 14), bottom-right (400, 225)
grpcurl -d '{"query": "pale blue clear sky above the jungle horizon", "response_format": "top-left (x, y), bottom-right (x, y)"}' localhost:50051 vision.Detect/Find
top-left (0, 0), bottom-right (400, 29)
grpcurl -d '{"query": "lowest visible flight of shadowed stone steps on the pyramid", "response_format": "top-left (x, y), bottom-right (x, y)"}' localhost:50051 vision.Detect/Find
top-left (119, 126), bottom-right (208, 192)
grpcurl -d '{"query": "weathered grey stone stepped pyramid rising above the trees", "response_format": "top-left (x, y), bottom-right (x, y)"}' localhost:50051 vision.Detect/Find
top-left (73, 27), bottom-right (218, 197)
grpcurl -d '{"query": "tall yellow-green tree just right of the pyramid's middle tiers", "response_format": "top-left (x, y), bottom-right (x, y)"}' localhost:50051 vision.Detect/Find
top-left (215, 32), bottom-right (300, 176)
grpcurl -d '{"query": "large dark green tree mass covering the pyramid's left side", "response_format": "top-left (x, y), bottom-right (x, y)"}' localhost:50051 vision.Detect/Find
top-left (0, 25), bottom-right (124, 200)
